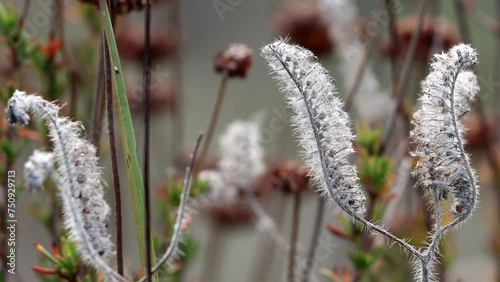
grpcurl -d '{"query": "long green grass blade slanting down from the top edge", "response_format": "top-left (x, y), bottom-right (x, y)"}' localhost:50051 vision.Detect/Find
top-left (99, 0), bottom-right (156, 276)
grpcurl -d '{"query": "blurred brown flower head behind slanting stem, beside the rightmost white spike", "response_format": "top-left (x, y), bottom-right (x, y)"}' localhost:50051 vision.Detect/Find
top-left (381, 16), bottom-right (461, 63)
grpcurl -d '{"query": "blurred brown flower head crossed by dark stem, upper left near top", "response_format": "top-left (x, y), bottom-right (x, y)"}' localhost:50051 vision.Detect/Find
top-left (116, 20), bottom-right (177, 62)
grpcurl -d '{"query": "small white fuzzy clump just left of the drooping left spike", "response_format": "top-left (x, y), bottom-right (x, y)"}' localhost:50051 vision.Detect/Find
top-left (24, 150), bottom-right (54, 191)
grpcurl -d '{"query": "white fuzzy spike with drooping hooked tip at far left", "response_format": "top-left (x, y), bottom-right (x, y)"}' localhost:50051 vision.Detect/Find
top-left (6, 90), bottom-right (127, 281)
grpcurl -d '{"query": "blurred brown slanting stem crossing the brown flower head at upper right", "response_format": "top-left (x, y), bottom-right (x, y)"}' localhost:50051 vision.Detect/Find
top-left (380, 0), bottom-right (429, 153)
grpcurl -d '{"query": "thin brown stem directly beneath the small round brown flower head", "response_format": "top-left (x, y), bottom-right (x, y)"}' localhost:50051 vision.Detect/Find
top-left (193, 75), bottom-right (228, 176)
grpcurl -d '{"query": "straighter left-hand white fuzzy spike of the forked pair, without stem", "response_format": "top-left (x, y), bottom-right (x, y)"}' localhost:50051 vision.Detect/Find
top-left (261, 40), bottom-right (365, 217)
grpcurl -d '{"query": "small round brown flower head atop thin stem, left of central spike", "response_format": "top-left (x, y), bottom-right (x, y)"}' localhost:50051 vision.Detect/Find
top-left (214, 43), bottom-right (253, 78)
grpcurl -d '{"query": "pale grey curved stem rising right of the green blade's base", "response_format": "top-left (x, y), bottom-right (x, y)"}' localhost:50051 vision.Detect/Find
top-left (139, 133), bottom-right (203, 282)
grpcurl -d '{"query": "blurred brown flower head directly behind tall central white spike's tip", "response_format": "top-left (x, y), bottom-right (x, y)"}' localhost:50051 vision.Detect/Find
top-left (274, 3), bottom-right (334, 56)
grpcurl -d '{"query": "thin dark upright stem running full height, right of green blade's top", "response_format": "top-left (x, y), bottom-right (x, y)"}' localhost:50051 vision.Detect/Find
top-left (143, 0), bottom-right (152, 281)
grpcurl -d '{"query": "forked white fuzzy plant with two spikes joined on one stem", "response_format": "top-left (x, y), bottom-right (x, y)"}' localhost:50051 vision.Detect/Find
top-left (261, 40), bottom-right (479, 282)
